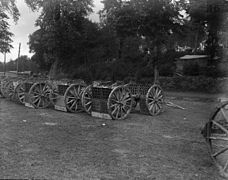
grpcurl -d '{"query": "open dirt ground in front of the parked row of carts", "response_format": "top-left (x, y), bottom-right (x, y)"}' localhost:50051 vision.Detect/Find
top-left (0, 99), bottom-right (222, 180)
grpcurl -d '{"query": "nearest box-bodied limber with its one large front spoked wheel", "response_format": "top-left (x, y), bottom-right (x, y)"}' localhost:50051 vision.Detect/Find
top-left (89, 82), bottom-right (132, 120)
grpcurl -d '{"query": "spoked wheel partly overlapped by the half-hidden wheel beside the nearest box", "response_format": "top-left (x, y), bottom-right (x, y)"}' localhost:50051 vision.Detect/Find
top-left (64, 84), bottom-right (85, 113)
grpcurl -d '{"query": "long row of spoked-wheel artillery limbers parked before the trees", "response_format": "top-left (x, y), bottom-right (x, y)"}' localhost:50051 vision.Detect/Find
top-left (0, 78), bottom-right (164, 120)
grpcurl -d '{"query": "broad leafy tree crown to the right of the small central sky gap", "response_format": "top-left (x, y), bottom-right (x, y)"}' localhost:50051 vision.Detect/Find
top-left (101, 0), bottom-right (187, 79)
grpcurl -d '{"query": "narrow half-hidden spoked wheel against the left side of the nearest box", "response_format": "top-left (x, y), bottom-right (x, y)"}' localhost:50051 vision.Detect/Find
top-left (82, 85), bottom-right (92, 114)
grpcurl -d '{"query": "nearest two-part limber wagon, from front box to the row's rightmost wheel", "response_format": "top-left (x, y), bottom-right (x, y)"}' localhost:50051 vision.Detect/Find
top-left (88, 82), bottom-right (164, 119)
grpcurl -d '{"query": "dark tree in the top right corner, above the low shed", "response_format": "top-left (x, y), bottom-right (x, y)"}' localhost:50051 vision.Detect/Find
top-left (189, 0), bottom-right (228, 60)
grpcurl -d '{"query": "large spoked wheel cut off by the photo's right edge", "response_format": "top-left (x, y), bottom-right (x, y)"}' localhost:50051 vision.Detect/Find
top-left (202, 102), bottom-right (228, 177)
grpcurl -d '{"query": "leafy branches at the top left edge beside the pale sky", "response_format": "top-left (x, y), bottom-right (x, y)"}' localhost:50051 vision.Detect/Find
top-left (0, 0), bottom-right (19, 53)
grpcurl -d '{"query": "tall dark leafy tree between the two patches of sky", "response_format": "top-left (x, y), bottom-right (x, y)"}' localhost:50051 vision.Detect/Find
top-left (26, 0), bottom-right (92, 73)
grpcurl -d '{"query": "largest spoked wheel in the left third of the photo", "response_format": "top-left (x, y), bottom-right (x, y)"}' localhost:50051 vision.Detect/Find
top-left (29, 82), bottom-right (52, 109)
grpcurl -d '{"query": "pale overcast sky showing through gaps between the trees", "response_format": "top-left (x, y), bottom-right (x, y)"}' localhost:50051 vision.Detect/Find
top-left (0, 0), bottom-right (103, 62)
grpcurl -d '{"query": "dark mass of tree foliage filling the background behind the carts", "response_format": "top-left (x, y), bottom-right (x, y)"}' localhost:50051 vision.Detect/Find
top-left (26, 0), bottom-right (227, 84)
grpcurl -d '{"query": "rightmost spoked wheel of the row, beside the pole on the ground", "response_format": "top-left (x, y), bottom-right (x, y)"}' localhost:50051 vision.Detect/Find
top-left (146, 84), bottom-right (164, 116)
